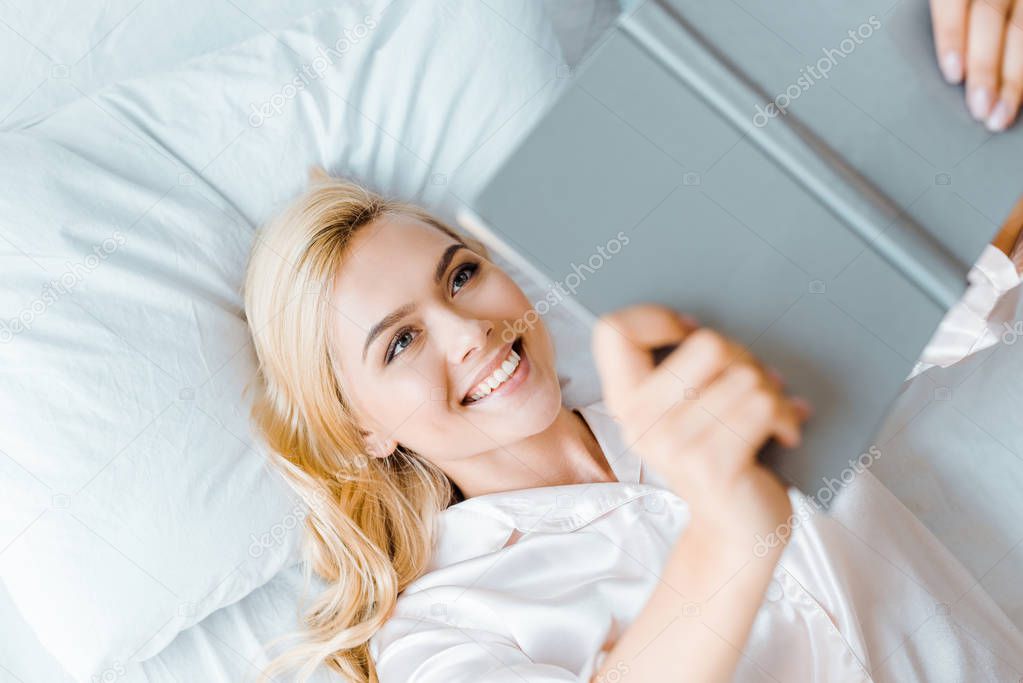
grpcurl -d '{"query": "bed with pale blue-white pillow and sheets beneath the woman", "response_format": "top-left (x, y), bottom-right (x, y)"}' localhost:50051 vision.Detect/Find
top-left (0, 0), bottom-right (1023, 683)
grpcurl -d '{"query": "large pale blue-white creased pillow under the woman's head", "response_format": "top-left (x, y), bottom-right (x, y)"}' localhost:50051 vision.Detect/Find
top-left (0, 0), bottom-right (605, 680)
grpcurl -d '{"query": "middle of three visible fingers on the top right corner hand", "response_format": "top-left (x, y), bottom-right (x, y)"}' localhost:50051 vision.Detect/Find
top-left (966, 0), bottom-right (1012, 121)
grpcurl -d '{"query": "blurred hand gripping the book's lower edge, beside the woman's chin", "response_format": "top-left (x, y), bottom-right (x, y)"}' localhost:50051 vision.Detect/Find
top-left (593, 305), bottom-right (809, 530)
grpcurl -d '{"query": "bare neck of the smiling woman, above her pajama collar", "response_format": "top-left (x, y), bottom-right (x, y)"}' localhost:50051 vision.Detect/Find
top-left (445, 406), bottom-right (617, 498)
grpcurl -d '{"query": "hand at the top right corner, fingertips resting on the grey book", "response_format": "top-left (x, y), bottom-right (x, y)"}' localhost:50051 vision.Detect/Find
top-left (931, 0), bottom-right (1023, 132)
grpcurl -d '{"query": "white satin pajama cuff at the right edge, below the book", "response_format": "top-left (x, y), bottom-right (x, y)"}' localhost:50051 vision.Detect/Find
top-left (906, 244), bottom-right (1023, 379)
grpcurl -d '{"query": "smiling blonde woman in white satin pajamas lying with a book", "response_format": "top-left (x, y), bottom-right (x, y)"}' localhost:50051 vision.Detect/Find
top-left (246, 176), bottom-right (1023, 683)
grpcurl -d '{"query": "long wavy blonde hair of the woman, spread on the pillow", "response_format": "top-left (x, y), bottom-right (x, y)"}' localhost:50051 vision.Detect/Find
top-left (244, 170), bottom-right (487, 683)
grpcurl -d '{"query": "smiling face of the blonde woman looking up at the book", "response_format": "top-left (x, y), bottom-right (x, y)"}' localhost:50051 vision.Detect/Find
top-left (331, 215), bottom-right (562, 468)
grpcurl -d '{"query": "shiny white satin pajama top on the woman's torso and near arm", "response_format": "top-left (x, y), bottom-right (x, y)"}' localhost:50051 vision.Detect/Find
top-left (369, 244), bottom-right (1023, 683)
